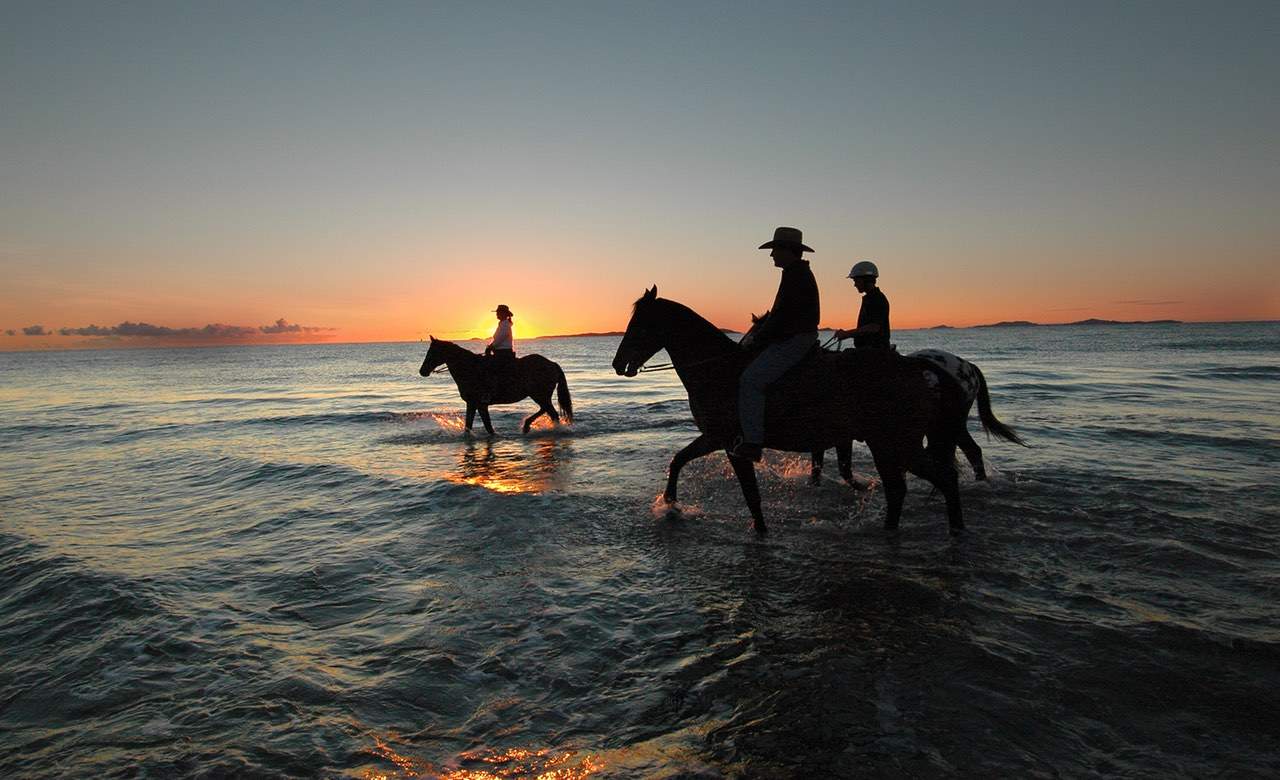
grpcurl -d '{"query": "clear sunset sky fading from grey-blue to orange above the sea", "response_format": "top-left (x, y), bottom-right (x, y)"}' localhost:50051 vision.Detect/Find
top-left (0, 0), bottom-right (1280, 350)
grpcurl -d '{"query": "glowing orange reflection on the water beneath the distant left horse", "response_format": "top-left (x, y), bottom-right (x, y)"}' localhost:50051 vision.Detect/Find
top-left (444, 438), bottom-right (570, 493)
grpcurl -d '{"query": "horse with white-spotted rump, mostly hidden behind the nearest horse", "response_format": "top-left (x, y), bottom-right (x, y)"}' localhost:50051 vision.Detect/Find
top-left (809, 350), bottom-right (1027, 484)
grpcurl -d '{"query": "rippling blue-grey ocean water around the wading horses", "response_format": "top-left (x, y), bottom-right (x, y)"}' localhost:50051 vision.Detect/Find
top-left (0, 318), bottom-right (1280, 779)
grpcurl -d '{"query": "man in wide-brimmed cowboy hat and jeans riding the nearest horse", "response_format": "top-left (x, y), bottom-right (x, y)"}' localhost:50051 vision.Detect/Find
top-left (732, 228), bottom-right (819, 461)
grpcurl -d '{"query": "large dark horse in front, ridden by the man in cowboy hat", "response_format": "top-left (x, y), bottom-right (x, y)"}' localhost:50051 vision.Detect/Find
top-left (613, 287), bottom-right (964, 533)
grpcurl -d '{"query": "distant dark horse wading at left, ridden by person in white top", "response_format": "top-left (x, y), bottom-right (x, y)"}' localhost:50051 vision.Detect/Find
top-left (417, 336), bottom-right (573, 435)
